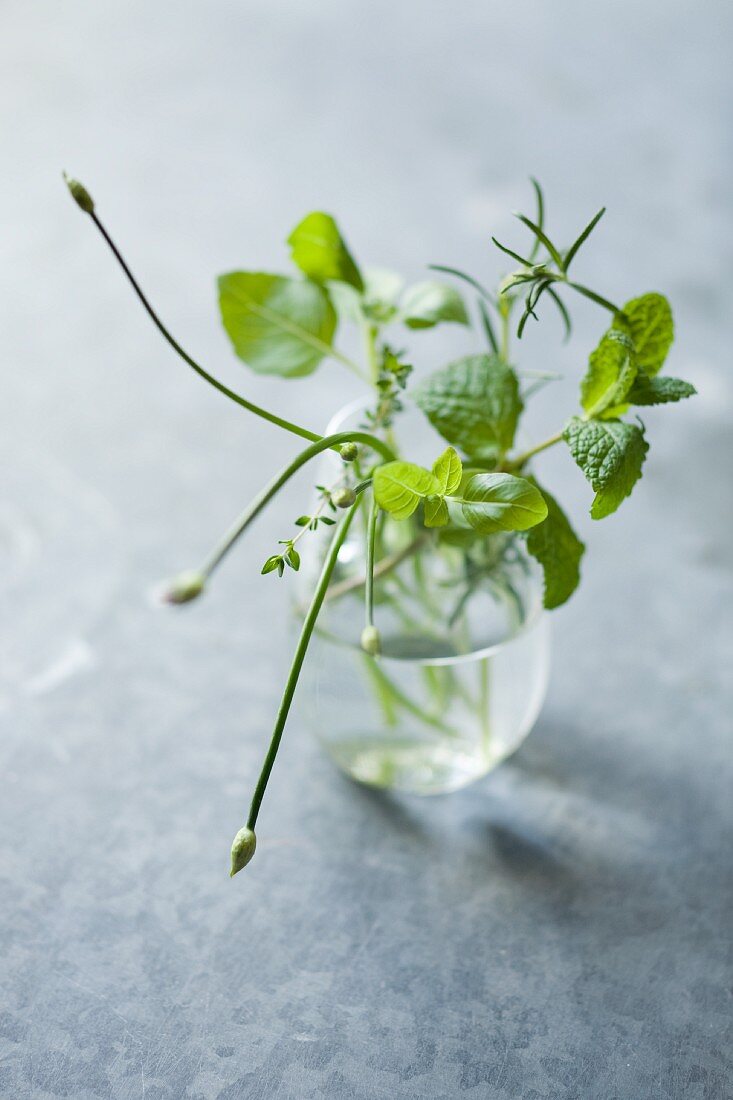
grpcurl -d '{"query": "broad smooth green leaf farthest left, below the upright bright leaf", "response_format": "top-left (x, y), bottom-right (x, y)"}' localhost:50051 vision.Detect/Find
top-left (218, 272), bottom-right (336, 378)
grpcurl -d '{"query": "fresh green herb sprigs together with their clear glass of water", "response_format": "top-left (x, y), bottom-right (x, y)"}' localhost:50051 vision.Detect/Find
top-left (62, 173), bottom-right (694, 875)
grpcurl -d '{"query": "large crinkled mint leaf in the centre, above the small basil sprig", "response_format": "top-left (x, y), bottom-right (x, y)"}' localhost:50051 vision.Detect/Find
top-left (413, 355), bottom-right (523, 459)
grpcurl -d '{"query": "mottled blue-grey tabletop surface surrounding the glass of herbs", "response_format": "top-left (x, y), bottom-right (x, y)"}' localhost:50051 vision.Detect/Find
top-left (0, 0), bottom-right (733, 1100)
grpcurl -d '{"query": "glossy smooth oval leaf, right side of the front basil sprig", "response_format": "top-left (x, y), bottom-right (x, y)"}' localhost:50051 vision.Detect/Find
top-left (461, 474), bottom-right (547, 535)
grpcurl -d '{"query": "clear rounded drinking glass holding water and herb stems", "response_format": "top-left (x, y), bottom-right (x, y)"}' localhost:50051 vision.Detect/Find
top-left (299, 406), bottom-right (549, 794)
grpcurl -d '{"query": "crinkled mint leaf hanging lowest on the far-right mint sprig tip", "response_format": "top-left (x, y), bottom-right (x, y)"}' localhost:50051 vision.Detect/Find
top-left (564, 417), bottom-right (649, 519)
